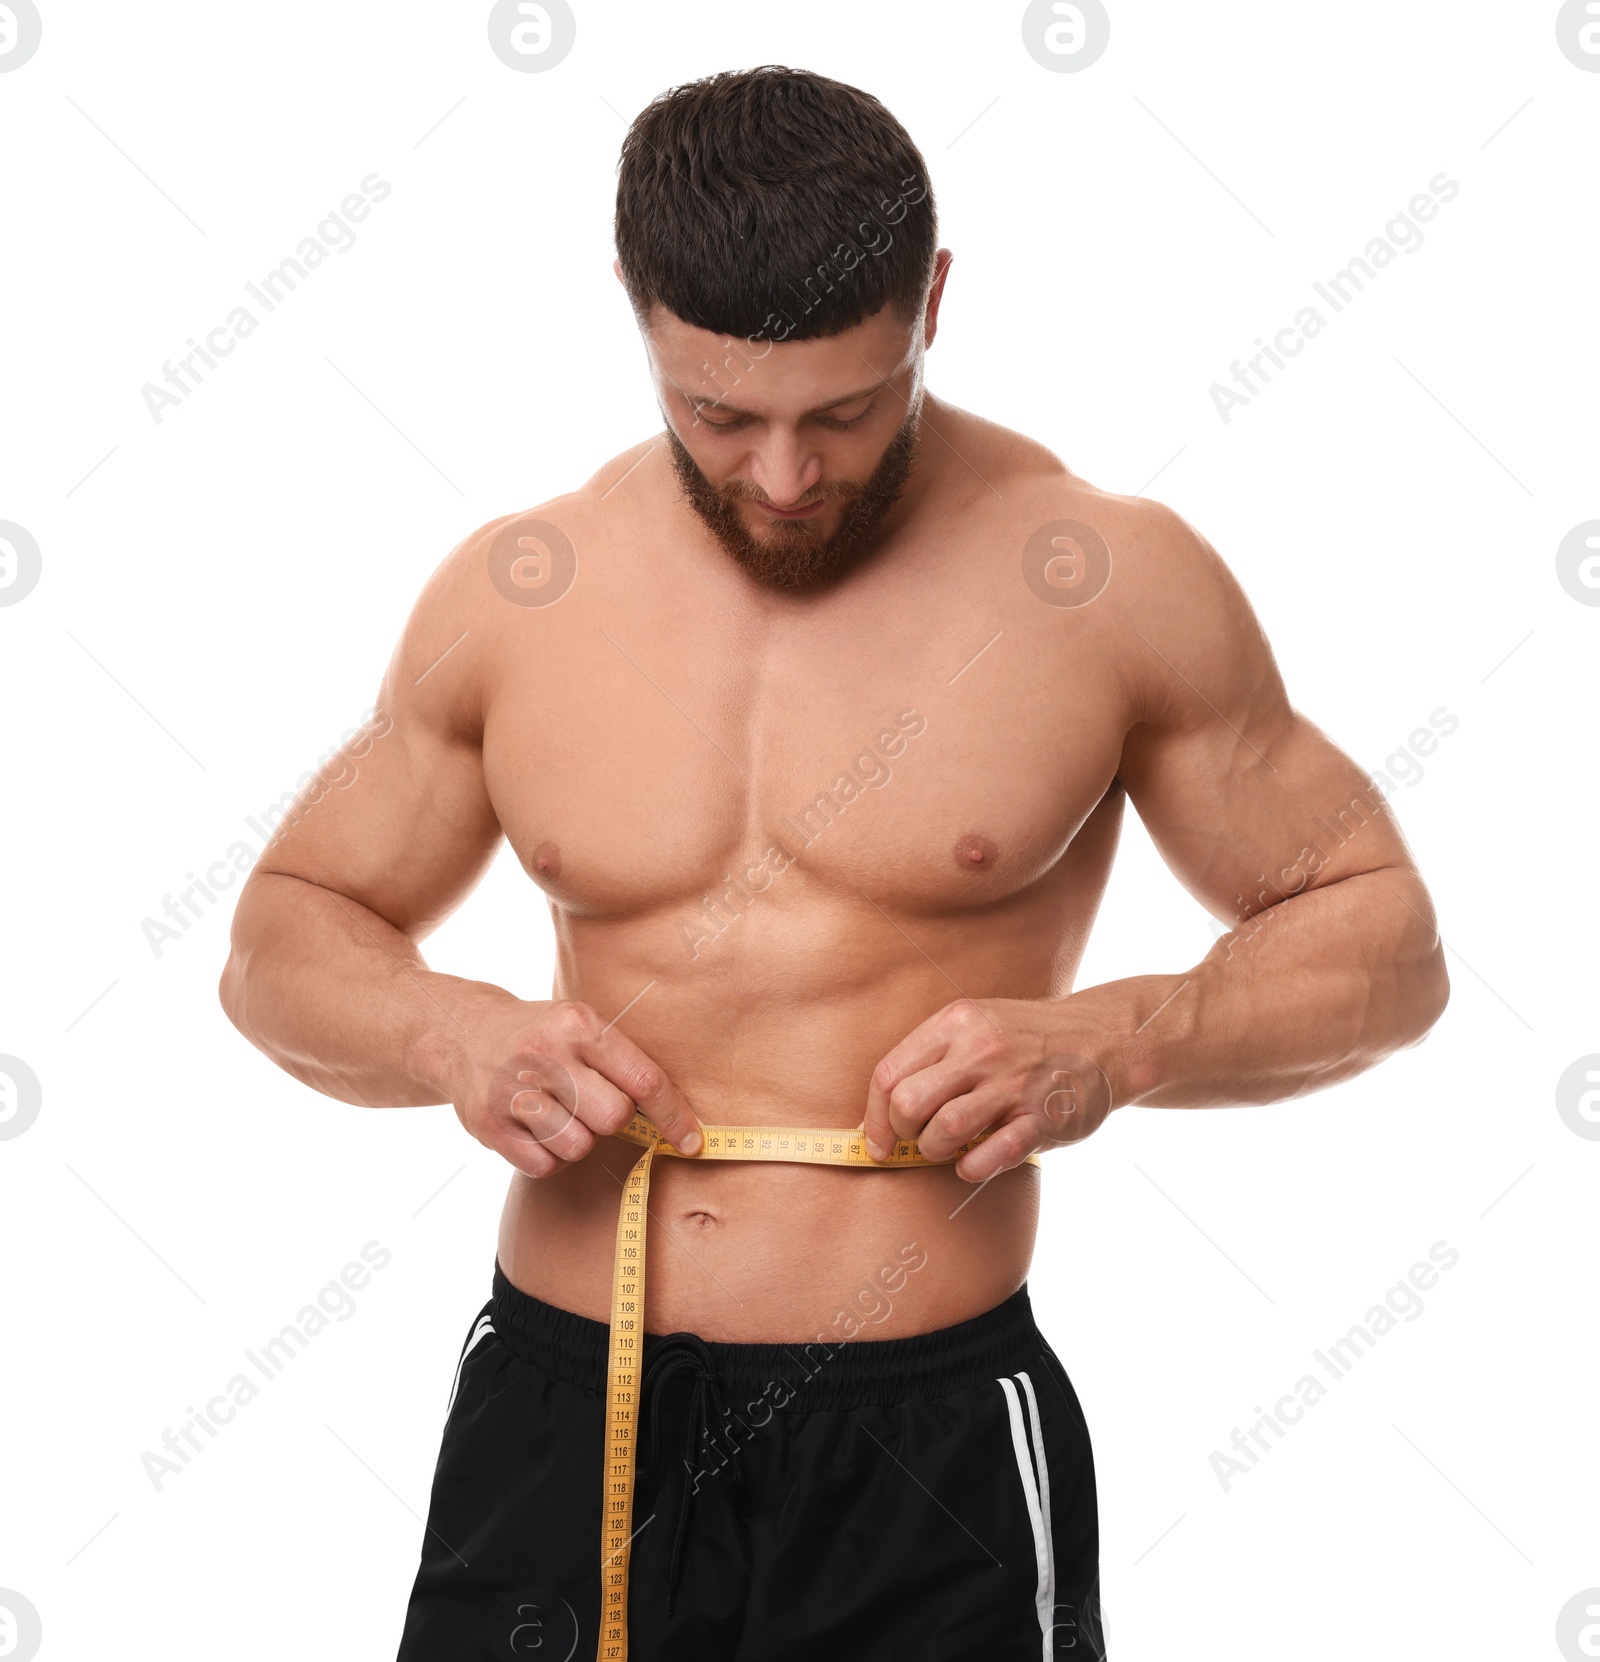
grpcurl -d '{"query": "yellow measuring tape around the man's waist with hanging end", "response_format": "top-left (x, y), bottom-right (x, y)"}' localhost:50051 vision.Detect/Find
top-left (596, 1114), bottom-right (1040, 1662)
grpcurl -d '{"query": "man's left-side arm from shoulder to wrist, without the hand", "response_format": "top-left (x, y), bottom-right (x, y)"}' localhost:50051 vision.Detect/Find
top-left (221, 525), bottom-right (500, 1105)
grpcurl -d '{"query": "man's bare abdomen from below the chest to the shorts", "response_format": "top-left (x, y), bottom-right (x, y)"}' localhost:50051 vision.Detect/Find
top-left (498, 857), bottom-right (1088, 1343)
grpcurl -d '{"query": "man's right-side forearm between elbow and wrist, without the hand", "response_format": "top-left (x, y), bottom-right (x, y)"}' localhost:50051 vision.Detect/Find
top-left (1067, 868), bottom-right (1449, 1109)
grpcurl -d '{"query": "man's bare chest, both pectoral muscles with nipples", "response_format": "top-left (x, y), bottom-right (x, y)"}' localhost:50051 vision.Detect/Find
top-left (483, 578), bottom-right (1128, 917)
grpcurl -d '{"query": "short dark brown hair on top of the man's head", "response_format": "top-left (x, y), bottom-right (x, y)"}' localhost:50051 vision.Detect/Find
top-left (616, 63), bottom-right (939, 341)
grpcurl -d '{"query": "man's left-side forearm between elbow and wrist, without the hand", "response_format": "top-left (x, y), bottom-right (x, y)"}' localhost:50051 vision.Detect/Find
top-left (219, 873), bottom-right (517, 1107)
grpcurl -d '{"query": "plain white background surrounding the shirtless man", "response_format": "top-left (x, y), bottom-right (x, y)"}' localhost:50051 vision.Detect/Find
top-left (0, 0), bottom-right (1600, 1662)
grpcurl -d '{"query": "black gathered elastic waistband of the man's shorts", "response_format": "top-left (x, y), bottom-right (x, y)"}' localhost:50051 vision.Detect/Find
top-left (490, 1261), bottom-right (1047, 1414)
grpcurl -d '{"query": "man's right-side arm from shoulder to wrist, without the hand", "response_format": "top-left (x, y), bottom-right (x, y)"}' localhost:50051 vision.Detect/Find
top-left (1075, 505), bottom-right (1449, 1107)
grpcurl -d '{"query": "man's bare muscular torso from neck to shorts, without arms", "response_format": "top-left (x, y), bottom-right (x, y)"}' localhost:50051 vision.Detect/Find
top-left (445, 398), bottom-right (1148, 1340)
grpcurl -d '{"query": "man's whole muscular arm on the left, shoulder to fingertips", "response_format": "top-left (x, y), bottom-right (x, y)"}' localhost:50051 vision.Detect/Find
top-left (219, 522), bottom-right (694, 1177)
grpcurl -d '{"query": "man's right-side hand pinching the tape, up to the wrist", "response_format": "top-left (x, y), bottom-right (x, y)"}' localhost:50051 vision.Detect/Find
top-left (864, 999), bottom-right (1113, 1183)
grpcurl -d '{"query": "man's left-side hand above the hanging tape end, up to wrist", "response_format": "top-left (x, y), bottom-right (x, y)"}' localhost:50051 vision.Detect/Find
top-left (442, 999), bottom-right (701, 1177)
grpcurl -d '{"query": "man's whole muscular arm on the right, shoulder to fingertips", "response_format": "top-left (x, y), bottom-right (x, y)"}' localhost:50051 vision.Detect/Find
top-left (866, 502), bottom-right (1449, 1182)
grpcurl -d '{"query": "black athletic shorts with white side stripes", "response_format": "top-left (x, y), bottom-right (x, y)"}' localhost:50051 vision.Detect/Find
top-left (399, 1263), bottom-right (1105, 1662)
